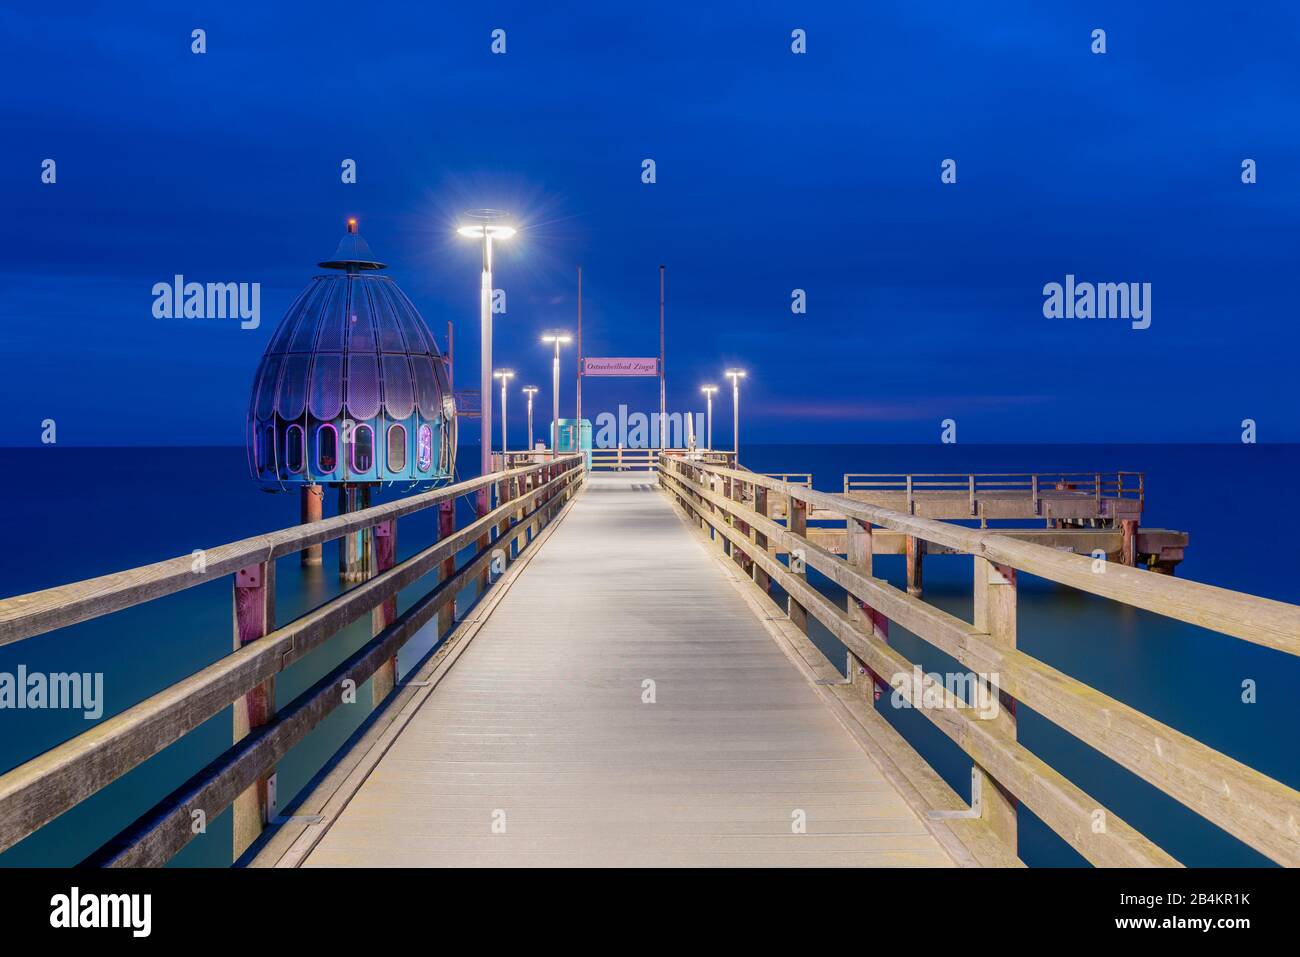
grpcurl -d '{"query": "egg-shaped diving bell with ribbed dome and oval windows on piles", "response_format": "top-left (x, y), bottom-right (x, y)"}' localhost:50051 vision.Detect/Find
top-left (247, 220), bottom-right (456, 580)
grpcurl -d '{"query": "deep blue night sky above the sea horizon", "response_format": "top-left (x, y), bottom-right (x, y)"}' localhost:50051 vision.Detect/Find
top-left (0, 1), bottom-right (1300, 445)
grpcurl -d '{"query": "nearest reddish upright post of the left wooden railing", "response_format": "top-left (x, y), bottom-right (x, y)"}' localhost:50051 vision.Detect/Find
top-left (230, 560), bottom-right (276, 861)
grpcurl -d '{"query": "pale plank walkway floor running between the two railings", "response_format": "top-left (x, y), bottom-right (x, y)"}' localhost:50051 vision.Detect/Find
top-left (271, 472), bottom-right (952, 867)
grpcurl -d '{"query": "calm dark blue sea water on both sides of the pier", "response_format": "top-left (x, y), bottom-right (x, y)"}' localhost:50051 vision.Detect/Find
top-left (0, 445), bottom-right (1300, 866)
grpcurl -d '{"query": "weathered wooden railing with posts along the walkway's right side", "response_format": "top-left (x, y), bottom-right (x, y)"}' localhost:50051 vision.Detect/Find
top-left (659, 458), bottom-right (1300, 866)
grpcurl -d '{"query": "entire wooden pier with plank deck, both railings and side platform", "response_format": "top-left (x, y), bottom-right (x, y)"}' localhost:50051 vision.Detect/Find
top-left (0, 450), bottom-right (1300, 867)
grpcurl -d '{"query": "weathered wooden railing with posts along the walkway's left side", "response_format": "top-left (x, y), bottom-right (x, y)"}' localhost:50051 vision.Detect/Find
top-left (0, 455), bottom-right (585, 866)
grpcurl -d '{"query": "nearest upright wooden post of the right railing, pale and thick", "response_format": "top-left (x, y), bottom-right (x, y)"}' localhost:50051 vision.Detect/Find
top-left (970, 555), bottom-right (1018, 853)
